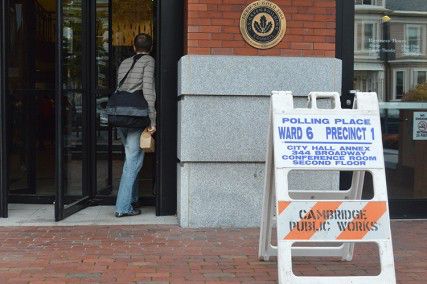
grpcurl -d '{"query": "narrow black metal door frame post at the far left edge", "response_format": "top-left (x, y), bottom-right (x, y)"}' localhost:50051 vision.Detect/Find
top-left (0, 0), bottom-right (9, 218)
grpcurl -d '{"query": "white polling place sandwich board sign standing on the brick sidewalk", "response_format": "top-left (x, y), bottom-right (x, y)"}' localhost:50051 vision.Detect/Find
top-left (259, 92), bottom-right (396, 284)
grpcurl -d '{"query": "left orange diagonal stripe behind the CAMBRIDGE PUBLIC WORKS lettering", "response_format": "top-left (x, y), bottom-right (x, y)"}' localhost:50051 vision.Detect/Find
top-left (284, 201), bottom-right (342, 240)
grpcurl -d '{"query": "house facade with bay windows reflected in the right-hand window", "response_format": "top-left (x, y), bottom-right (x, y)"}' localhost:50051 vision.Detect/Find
top-left (354, 0), bottom-right (427, 101)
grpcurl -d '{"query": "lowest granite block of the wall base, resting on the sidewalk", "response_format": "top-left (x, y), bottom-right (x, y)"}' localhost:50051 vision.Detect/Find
top-left (178, 163), bottom-right (339, 228)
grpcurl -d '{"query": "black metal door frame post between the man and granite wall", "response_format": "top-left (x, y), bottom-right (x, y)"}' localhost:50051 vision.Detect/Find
top-left (156, 0), bottom-right (185, 216)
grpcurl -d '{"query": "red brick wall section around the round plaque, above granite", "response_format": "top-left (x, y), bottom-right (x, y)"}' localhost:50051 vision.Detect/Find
top-left (185, 0), bottom-right (336, 57)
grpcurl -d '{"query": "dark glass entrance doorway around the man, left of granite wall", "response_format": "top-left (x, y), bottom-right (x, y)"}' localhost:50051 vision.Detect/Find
top-left (1, 0), bottom-right (182, 221)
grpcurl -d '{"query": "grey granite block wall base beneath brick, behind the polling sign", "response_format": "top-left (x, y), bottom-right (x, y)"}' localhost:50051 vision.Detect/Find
top-left (177, 55), bottom-right (341, 228)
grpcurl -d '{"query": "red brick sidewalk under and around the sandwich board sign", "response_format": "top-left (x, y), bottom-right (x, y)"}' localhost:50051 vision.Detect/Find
top-left (0, 221), bottom-right (427, 284)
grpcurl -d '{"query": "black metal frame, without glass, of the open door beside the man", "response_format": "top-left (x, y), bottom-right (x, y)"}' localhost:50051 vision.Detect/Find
top-left (55, 0), bottom-right (92, 221)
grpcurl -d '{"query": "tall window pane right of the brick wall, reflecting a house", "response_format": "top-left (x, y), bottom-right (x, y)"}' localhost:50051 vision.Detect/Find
top-left (354, 0), bottom-right (427, 199)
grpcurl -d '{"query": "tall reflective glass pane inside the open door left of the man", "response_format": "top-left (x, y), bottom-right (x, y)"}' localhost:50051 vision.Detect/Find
top-left (62, 0), bottom-right (86, 199)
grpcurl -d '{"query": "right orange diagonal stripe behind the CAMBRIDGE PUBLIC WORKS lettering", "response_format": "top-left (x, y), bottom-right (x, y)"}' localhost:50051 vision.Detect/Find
top-left (337, 201), bottom-right (387, 240)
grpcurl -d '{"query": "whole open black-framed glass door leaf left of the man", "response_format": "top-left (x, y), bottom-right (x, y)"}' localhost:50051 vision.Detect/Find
top-left (55, 0), bottom-right (91, 221)
